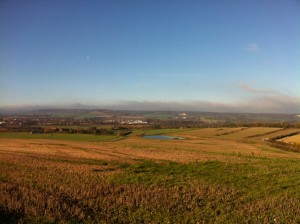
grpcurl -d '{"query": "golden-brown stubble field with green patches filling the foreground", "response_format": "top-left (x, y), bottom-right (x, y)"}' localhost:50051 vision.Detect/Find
top-left (0, 128), bottom-right (300, 223)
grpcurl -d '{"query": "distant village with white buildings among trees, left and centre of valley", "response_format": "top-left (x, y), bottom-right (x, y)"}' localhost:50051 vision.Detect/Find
top-left (0, 113), bottom-right (199, 134)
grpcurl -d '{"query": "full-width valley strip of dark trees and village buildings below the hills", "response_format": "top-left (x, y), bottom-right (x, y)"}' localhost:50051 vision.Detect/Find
top-left (0, 110), bottom-right (300, 134)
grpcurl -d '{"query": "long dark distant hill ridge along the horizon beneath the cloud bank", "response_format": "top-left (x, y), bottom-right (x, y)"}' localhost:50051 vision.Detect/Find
top-left (0, 108), bottom-right (300, 122)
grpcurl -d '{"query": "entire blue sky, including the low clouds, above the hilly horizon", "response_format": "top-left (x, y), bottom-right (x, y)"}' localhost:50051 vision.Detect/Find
top-left (0, 0), bottom-right (300, 113)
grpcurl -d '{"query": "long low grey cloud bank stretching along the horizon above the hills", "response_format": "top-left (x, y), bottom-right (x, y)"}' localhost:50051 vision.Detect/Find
top-left (0, 95), bottom-right (300, 114)
